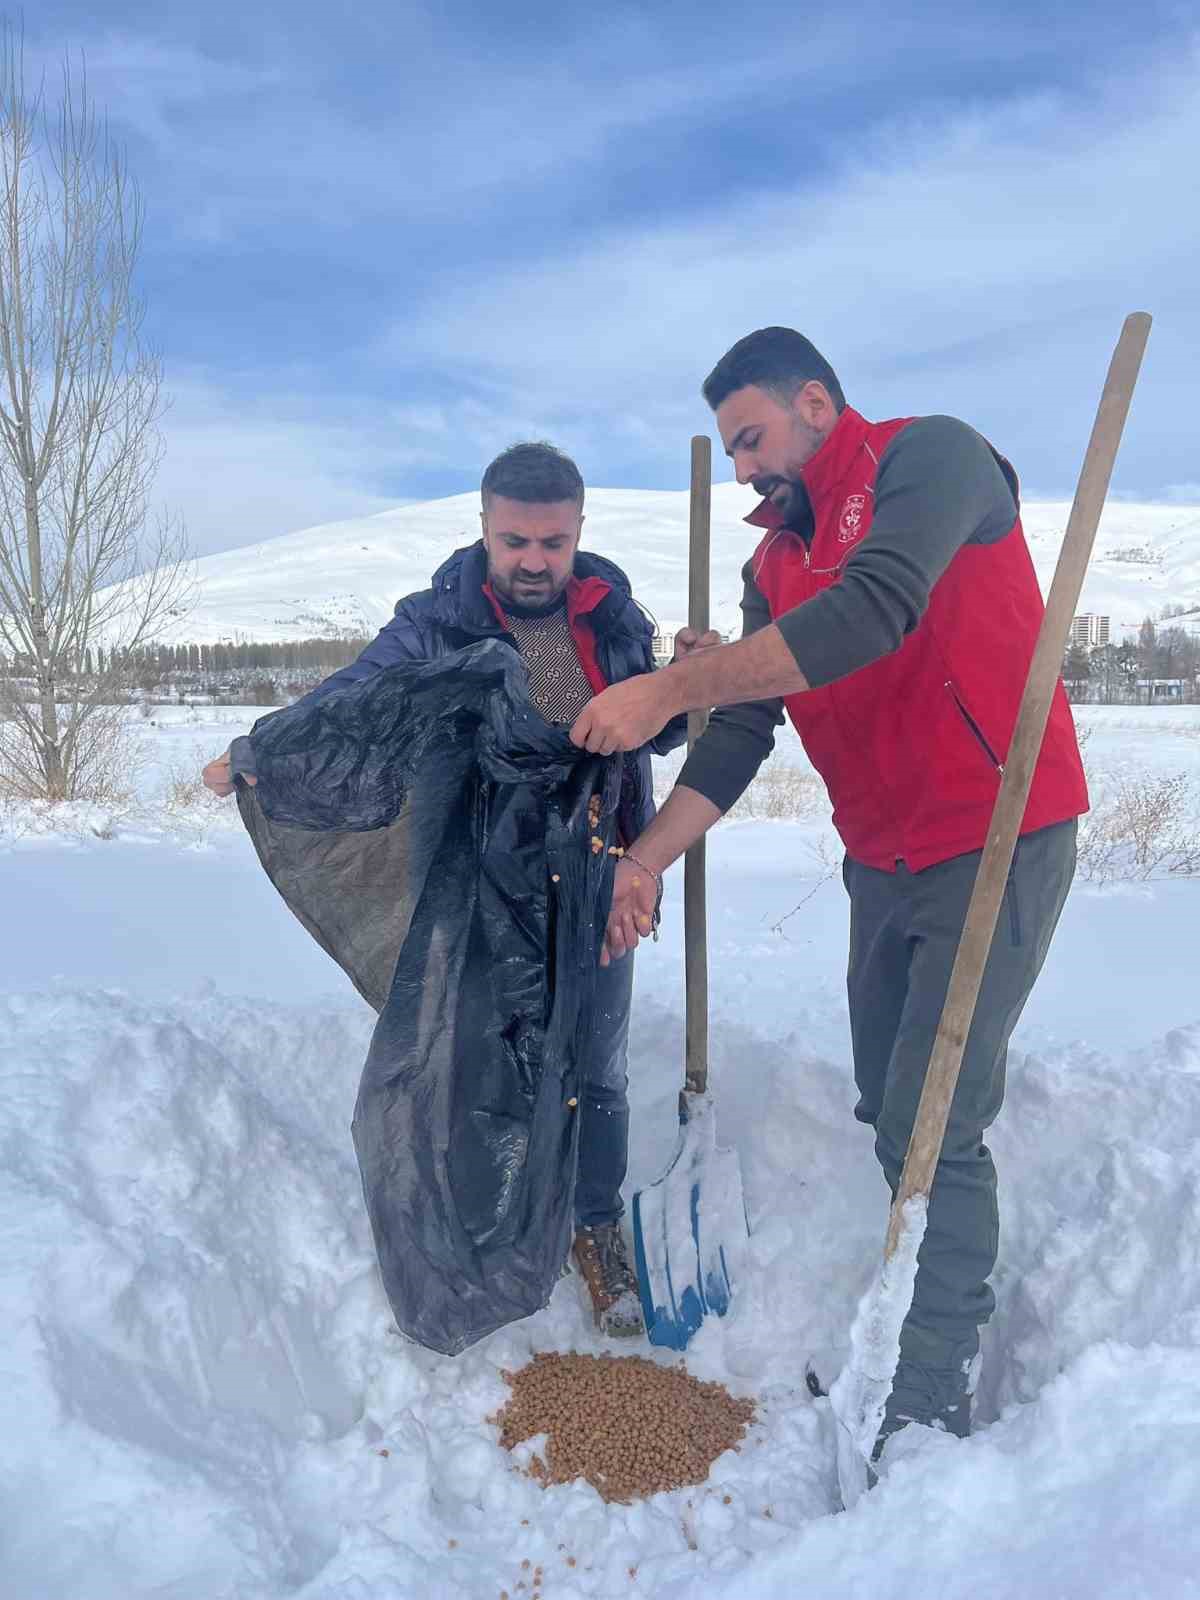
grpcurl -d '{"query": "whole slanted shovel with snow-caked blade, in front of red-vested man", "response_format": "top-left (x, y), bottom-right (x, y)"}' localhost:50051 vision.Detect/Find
top-left (829, 312), bottom-right (1150, 1509)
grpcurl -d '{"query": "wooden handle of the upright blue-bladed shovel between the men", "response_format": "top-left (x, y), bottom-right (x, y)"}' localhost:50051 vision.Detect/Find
top-left (683, 434), bottom-right (712, 1094)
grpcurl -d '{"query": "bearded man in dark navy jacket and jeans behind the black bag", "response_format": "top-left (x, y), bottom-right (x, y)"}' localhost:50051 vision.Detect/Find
top-left (203, 443), bottom-right (718, 1338)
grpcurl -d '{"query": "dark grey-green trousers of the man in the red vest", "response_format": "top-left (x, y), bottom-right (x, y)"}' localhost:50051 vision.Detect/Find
top-left (843, 821), bottom-right (1077, 1370)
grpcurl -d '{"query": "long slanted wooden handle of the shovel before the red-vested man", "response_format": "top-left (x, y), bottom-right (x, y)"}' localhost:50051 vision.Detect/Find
top-left (885, 312), bottom-right (1150, 1259)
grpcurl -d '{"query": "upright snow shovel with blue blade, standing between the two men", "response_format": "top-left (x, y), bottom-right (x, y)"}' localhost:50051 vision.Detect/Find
top-left (634, 435), bottom-right (749, 1350)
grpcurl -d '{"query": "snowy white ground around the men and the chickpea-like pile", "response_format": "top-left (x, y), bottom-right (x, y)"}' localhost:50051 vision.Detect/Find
top-left (0, 707), bottom-right (1200, 1600)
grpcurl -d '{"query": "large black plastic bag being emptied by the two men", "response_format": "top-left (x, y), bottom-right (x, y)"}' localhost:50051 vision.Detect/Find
top-left (238, 640), bottom-right (621, 1355)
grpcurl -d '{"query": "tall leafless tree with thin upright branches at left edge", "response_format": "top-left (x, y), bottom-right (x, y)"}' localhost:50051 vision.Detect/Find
top-left (0, 24), bottom-right (190, 800)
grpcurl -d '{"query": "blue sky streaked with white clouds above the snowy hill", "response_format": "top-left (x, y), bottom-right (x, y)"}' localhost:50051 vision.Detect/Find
top-left (26, 0), bottom-right (1200, 552)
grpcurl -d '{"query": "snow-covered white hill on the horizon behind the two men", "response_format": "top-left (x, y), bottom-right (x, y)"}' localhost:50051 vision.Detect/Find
top-left (152, 483), bottom-right (1200, 643)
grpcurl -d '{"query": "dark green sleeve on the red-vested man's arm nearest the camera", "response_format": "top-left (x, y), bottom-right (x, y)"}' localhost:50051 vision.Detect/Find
top-left (778, 416), bottom-right (1016, 688)
